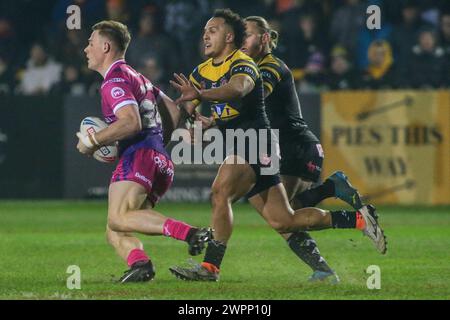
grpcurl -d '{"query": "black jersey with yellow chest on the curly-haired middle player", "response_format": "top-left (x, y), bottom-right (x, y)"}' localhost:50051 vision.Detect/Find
top-left (189, 50), bottom-right (269, 130)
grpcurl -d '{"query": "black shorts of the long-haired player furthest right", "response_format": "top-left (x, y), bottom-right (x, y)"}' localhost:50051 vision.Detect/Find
top-left (280, 141), bottom-right (324, 182)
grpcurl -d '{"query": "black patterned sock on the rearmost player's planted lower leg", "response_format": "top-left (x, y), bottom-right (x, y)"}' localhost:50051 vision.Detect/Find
top-left (287, 232), bottom-right (333, 272)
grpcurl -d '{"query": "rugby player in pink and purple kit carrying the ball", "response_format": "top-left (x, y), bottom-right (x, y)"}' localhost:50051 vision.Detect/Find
top-left (77, 21), bottom-right (211, 283)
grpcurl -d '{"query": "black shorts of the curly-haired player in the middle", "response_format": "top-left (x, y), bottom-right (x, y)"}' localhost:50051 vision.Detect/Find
top-left (225, 127), bottom-right (281, 198)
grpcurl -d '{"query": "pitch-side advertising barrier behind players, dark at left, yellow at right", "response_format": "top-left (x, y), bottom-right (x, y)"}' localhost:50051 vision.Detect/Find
top-left (0, 91), bottom-right (450, 204)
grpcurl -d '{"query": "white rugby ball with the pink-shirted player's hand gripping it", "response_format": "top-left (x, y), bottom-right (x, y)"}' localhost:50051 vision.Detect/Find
top-left (77, 117), bottom-right (118, 163)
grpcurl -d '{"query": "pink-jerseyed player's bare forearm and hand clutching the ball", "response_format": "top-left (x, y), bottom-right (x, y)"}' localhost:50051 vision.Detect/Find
top-left (77, 104), bottom-right (142, 155)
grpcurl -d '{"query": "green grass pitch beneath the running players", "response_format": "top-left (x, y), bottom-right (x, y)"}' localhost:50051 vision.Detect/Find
top-left (0, 201), bottom-right (450, 300)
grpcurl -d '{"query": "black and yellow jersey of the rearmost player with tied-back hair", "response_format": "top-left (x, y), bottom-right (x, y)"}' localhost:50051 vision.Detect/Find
top-left (258, 53), bottom-right (318, 143)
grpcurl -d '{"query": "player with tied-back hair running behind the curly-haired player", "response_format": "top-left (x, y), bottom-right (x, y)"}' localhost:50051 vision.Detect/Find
top-left (241, 16), bottom-right (372, 281)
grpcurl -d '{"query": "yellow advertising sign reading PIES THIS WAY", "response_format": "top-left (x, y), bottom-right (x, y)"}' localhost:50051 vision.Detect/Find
top-left (321, 91), bottom-right (450, 204)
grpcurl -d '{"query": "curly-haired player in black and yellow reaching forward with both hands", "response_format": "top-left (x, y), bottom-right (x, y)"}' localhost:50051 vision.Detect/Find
top-left (170, 9), bottom-right (385, 281)
